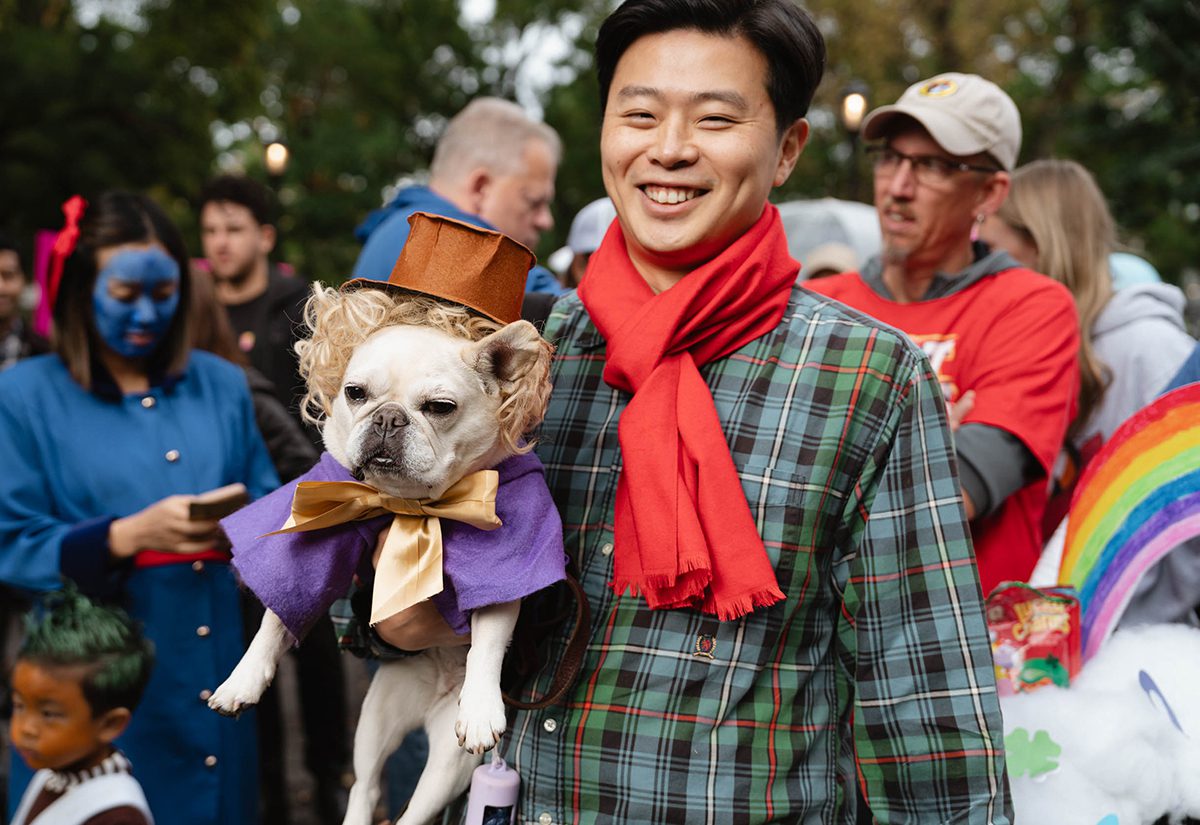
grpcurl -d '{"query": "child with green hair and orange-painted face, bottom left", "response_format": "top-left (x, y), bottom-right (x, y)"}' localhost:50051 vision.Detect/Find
top-left (10, 586), bottom-right (154, 825)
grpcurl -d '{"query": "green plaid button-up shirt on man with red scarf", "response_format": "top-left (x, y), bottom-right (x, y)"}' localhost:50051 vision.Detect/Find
top-left (502, 288), bottom-right (1012, 825)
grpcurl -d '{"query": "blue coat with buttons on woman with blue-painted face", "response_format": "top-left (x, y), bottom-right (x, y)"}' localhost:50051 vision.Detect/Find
top-left (0, 351), bottom-right (278, 825)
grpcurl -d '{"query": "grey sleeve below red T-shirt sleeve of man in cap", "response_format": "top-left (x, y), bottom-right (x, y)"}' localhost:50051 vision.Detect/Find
top-left (954, 424), bottom-right (1045, 518)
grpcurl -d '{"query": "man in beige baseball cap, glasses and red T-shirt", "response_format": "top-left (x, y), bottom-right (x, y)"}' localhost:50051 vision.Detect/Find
top-left (806, 72), bottom-right (1079, 595)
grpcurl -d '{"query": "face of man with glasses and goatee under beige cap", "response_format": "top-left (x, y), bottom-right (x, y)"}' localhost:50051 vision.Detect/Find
top-left (875, 126), bottom-right (996, 269)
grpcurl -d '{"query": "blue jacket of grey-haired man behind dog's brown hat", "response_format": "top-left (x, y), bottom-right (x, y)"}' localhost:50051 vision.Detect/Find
top-left (353, 186), bottom-right (566, 295)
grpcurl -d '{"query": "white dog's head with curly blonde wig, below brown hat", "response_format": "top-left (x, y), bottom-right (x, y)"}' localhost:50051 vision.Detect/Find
top-left (298, 288), bottom-right (551, 499)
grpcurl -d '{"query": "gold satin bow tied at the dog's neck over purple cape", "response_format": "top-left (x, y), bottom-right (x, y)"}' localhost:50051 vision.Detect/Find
top-left (266, 470), bottom-right (503, 626)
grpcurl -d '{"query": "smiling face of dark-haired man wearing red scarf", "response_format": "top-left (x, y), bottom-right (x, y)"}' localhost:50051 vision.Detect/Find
top-left (600, 29), bottom-right (808, 280)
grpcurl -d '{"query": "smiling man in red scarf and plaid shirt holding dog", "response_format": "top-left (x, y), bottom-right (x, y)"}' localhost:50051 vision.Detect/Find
top-left (477, 0), bottom-right (1010, 825)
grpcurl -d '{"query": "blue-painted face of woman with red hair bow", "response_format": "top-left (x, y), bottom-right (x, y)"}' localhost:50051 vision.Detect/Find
top-left (91, 247), bottom-right (179, 359)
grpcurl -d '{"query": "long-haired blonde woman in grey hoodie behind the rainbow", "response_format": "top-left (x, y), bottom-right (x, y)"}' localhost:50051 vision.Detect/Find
top-left (980, 161), bottom-right (1200, 625)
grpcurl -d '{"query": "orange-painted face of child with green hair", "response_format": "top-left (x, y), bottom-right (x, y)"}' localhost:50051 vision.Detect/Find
top-left (8, 662), bottom-right (112, 770)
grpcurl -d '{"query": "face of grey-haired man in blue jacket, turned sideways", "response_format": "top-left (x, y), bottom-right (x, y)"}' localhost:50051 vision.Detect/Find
top-left (479, 139), bottom-right (558, 249)
